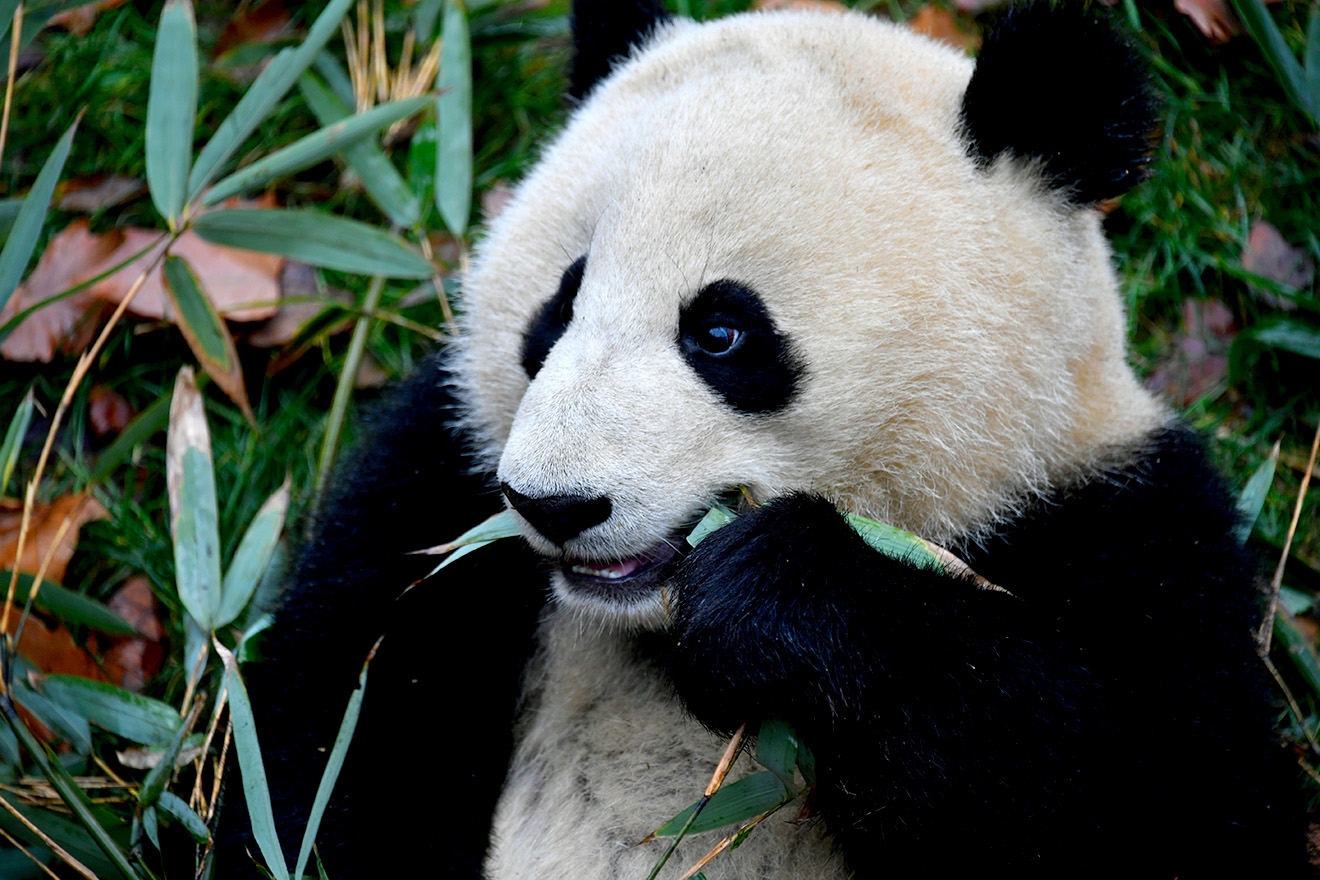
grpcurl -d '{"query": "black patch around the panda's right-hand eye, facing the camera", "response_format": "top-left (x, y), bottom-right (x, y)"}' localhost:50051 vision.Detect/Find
top-left (678, 281), bottom-right (805, 416)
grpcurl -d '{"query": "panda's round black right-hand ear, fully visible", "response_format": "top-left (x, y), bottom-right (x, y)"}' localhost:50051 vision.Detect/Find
top-left (962, 1), bottom-right (1156, 204)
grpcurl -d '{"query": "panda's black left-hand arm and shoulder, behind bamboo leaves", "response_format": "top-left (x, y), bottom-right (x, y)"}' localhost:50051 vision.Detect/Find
top-left (215, 353), bottom-right (548, 880)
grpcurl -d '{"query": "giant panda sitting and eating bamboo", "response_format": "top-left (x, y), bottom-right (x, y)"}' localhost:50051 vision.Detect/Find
top-left (218, 0), bottom-right (1303, 880)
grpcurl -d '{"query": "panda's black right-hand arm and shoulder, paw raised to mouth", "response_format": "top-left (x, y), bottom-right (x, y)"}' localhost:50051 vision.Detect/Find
top-left (669, 430), bottom-right (1303, 877)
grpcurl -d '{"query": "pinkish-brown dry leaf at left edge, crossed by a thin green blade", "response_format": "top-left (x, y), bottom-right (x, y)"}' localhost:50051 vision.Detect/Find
top-left (0, 220), bottom-right (123, 363)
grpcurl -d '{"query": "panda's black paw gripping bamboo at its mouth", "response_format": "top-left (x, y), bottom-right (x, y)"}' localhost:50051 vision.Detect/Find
top-left (668, 495), bottom-right (920, 732)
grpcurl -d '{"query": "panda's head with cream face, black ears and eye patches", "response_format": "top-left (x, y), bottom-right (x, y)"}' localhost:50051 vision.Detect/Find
top-left (453, 0), bottom-right (1164, 625)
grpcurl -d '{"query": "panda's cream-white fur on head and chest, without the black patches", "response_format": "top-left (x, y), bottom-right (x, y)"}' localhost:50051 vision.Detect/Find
top-left (455, 13), bottom-right (1166, 880)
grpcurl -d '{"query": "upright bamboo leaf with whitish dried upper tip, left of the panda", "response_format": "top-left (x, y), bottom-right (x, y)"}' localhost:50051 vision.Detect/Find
top-left (165, 367), bottom-right (220, 632)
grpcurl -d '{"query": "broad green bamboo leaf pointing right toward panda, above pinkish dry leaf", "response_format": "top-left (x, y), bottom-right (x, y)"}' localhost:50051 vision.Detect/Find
top-left (194, 210), bottom-right (434, 280)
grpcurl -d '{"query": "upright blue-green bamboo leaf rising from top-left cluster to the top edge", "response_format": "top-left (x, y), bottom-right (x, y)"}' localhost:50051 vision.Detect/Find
top-left (147, 0), bottom-right (197, 221)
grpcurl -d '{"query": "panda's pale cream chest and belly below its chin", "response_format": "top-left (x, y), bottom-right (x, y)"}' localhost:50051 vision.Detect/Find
top-left (486, 613), bottom-right (850, 880)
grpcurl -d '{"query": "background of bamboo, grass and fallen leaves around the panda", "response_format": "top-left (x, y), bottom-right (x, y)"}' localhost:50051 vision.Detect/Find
top-left (0, 0), bottom-right (1320, 879)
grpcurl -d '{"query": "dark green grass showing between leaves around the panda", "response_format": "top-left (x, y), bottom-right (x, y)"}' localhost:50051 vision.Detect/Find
top-left (0, 0), bottom-right (1320, 876)
